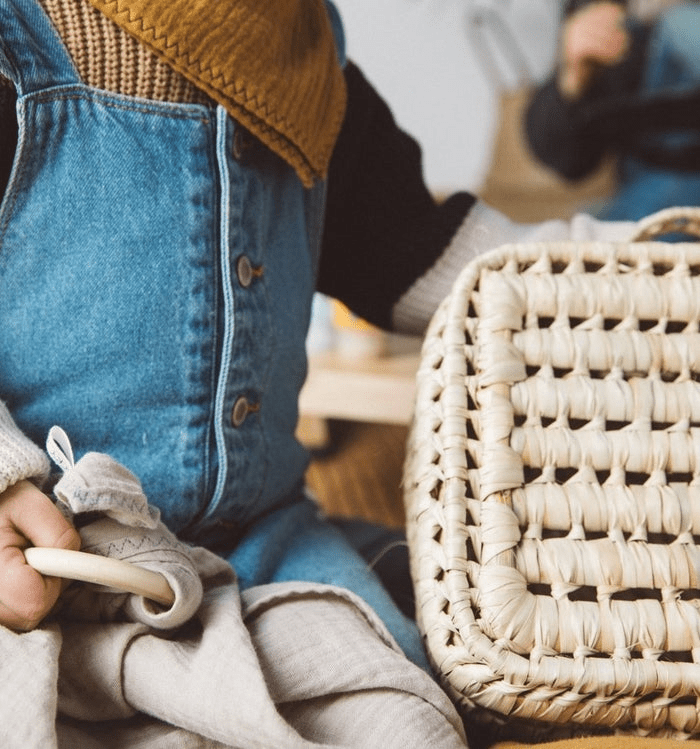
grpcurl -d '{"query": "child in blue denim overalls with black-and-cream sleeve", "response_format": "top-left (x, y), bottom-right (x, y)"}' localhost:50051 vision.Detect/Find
top-left (0, 0), bottom-right (629, 708)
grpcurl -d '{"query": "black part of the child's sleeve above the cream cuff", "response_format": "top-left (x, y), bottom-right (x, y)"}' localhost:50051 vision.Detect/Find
top-left (317, 63), bottom-right (475, 328)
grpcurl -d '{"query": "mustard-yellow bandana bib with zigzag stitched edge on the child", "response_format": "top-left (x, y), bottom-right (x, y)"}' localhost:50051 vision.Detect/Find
top-left (90, 0), bottom-right (346, 187)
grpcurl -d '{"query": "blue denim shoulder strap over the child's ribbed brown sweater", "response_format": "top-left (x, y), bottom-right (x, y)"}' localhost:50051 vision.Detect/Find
top-left (0, 0), bottom-right (80, 96)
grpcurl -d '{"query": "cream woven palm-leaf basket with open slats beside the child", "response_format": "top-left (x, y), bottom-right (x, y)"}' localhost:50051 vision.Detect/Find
top-left (404, 209), bottom-right (700, 737)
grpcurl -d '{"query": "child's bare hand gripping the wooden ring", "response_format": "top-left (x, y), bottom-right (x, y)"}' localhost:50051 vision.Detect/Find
top-left (0, 481), bottom-right (80, 630)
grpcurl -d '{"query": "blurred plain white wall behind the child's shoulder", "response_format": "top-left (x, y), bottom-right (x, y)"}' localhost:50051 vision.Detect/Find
top-left (335, 0), bottom-right (559, 192)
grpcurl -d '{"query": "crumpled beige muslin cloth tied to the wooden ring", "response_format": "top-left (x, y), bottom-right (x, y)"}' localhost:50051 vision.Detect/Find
top-left (0, 435), bottom-right (466, 749)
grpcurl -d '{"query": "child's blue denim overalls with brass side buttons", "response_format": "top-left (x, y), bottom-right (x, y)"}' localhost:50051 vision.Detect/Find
top-left (0, 0), bottom-right (425, 665)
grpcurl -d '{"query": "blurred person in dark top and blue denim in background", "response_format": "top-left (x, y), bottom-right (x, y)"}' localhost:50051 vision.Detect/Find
top-left (525, 0), bottom-right (700, 220)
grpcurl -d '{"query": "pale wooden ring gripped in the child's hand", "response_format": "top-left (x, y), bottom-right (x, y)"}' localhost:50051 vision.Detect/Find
top-left (24, 546), bottom-right (175, 606)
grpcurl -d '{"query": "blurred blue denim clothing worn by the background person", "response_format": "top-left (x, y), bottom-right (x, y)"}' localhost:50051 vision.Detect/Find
top-left (598, 5), bottom-right (700, 222)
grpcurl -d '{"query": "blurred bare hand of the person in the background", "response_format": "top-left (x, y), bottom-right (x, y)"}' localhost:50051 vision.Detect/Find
top-left (558, 0), bottom-right (629, 99)
